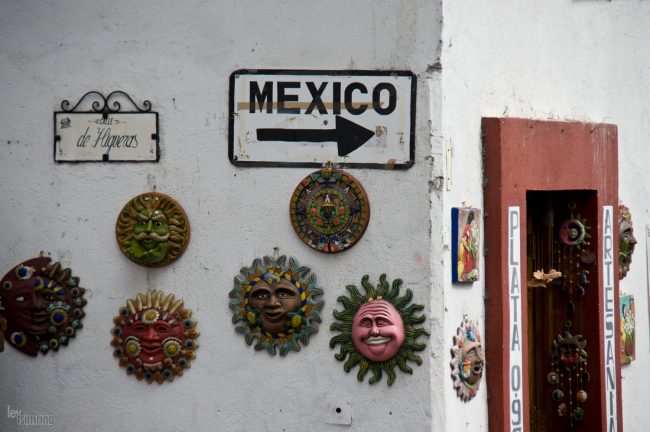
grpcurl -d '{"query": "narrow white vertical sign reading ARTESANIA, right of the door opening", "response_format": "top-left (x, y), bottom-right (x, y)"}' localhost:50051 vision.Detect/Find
top-left (603, 206), bottom-right (618, 432)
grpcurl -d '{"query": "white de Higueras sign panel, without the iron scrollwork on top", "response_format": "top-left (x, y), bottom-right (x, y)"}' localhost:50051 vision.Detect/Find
top-left (54, 112), bottom-right (158, 162)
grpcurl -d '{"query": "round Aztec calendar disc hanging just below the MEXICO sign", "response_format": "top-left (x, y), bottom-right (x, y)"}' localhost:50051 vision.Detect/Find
top-left (289, 164), bottom-right (370, 253)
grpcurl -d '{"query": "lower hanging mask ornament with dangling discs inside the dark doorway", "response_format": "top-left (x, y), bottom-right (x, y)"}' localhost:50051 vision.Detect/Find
top-left (546, 330), bottom-right (589, 428)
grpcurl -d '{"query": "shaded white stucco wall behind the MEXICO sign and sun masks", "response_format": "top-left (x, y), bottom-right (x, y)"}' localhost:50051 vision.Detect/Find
top-left (0, 0), bottom-right (440, 431)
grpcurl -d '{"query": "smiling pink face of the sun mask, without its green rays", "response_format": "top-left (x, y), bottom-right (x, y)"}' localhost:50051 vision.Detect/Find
top-left (352, 300), bottom-right (404, 362)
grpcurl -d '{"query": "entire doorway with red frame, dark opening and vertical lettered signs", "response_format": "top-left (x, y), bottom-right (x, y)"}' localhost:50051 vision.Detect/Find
top-left (482, 118), bottom-right (623, 432)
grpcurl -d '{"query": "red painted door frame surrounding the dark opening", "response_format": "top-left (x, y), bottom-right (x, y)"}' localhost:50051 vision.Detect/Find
top-left (482, 118), bottom-right (623, 432)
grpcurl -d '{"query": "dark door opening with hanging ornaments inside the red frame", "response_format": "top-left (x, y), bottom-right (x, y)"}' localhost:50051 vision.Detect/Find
top-left (526, 191), bottom-right (600, 432)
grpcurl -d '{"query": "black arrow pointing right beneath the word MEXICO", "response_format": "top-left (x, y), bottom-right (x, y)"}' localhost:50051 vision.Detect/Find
top-left (257, 116), bottom-right (375, 156)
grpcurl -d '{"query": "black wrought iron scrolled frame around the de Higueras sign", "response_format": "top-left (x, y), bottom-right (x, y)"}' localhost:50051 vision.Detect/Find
top-left (53, 90), bottom-right (160, 163)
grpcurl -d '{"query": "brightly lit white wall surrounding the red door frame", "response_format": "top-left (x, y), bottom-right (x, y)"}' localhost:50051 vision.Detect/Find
top-left (434, 0), bottom-right (650, 431)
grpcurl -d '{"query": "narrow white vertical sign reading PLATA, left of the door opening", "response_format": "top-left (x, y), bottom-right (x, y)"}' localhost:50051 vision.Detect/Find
top-left (508, 206), bottom-right (524, 432)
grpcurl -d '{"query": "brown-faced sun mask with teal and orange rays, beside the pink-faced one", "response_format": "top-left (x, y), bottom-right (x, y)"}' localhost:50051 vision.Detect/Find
top-left (230, 249), bottom-right (323, 356)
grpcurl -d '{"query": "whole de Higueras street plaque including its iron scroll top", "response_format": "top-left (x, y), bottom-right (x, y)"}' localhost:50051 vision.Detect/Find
top-left (54, 91), bottom-right (159, 162)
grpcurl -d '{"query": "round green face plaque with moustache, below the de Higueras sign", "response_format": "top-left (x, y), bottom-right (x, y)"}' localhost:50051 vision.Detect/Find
top-left (115, 192), bottom-right (190, 267)
